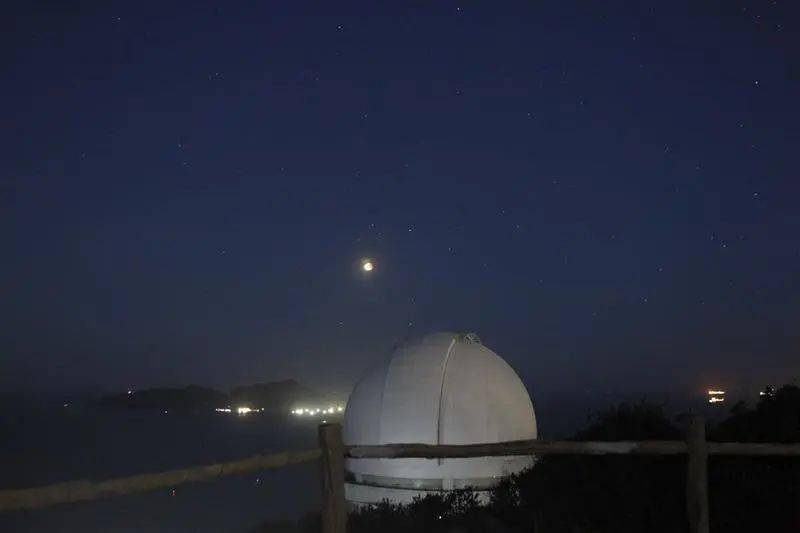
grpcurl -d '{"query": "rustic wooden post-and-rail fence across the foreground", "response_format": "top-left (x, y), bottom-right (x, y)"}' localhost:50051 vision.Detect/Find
top-left (0, 417), bottom-right (800, 533)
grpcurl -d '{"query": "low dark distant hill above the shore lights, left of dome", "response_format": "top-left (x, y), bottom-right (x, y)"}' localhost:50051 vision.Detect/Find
top-left (96, 379), bottom-right (321, 411)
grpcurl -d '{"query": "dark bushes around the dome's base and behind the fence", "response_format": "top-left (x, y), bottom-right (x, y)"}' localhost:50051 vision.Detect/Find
top-left (259, 385), bottom-right (800, 533)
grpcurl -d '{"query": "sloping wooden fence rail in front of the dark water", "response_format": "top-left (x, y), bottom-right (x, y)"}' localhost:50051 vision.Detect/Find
top-left (0, 449), bottom-right (320, 511)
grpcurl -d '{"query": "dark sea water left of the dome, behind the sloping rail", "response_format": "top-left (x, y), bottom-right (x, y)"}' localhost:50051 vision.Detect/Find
top-left (0, 405), bottom-right (319, 533)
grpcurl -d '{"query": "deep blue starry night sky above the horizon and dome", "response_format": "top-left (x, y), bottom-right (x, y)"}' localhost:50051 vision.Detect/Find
top-left (0, 0), bottom-right (800, 399)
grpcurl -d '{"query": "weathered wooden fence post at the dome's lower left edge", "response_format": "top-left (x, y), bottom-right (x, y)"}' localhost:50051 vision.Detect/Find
top-left (319, 424), bottom-right (347, 533)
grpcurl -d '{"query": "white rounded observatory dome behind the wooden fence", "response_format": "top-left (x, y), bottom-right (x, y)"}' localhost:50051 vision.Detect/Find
top-left (343, 333), bottom-right (536, 505)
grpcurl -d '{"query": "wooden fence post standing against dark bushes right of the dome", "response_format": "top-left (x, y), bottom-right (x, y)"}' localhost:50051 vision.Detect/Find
top-left (686, 416), bottom-right (709, 533)
